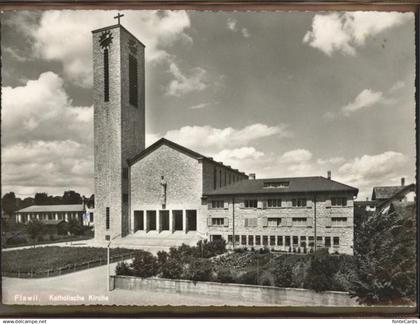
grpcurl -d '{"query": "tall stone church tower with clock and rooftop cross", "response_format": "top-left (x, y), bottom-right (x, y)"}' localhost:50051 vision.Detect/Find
top-left (92, 15), bottom-right (145, 241)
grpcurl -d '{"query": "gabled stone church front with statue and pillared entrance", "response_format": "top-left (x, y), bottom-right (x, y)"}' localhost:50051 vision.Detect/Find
top-left (126, 139), bottom-right (246, 242)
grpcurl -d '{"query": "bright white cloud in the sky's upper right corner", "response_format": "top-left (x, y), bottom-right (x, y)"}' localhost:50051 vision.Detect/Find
top-left (303, 11), bottom-right (414, 56)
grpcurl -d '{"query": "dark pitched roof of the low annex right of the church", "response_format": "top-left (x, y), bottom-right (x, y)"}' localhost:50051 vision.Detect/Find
top-left (204, 176), bottom-right (359, 196)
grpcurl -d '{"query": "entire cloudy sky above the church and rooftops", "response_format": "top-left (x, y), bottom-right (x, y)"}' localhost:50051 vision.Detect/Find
top-left (1, 11), bottom-right (415, 199)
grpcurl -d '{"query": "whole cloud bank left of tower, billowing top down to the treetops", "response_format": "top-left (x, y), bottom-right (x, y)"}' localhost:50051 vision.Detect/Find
top-left (2, 72), bottom-right (93, 194)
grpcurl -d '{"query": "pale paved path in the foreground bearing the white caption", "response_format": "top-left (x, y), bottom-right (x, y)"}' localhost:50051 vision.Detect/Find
top-left (2, 263), bottom-right (278, 306)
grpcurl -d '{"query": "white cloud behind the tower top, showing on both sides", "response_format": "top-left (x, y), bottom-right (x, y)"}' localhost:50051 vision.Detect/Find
top-left (11, 10), bottom-right (192, 87)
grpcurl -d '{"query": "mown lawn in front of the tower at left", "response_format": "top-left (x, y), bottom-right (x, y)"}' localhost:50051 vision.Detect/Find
top-left (1, 246), bottom-right (134, 277)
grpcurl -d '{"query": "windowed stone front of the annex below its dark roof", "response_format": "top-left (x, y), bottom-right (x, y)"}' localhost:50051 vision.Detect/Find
top-left (207, 193), bottom-right (353, 254)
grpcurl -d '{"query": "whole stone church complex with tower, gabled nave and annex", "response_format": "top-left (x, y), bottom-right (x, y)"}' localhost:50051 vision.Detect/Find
top-left (92, 22), bottom-right (358, 254)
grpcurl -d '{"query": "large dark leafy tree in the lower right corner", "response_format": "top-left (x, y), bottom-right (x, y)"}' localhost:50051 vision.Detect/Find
top-left (350, 202), bottom-right (416, 305)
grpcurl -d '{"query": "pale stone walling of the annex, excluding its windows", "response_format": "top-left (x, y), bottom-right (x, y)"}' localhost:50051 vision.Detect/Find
top-left (207, 193), bottom-right (353, 254)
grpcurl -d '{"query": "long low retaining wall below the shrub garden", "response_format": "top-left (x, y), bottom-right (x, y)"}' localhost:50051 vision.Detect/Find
top-left (111, 276), bottom-right (358, 306)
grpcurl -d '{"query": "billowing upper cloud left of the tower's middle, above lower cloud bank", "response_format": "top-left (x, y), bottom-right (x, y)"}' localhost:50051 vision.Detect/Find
top-left (2, 72), bottom-right (93, 145)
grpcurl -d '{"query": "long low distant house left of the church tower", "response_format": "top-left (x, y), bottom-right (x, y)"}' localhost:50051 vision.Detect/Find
top-left (16, 204), bottom-right (85, 223)
